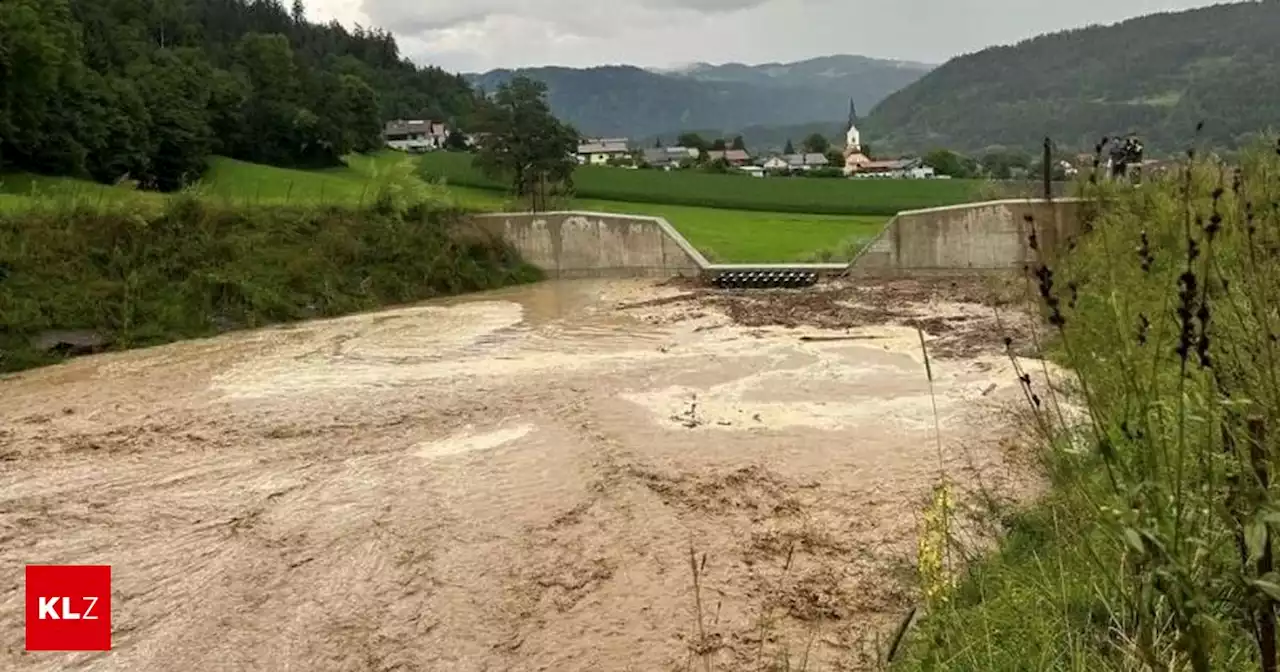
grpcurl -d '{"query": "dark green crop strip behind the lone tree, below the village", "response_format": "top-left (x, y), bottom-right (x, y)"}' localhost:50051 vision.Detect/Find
top-left (420, 152), bottom-right (984, 216)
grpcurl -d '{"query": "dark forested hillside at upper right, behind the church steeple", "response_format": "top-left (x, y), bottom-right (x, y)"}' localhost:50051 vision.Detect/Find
top-left (864, 0), bottom-right (1280, 151)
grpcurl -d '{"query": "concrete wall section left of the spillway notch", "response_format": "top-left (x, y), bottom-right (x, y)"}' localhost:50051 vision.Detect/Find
top-left (470, 211), bottom-right (708, 278)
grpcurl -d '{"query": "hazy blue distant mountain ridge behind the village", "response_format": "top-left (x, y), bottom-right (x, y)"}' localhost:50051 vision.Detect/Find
top-left (465, 55), bottom-right (932, 138)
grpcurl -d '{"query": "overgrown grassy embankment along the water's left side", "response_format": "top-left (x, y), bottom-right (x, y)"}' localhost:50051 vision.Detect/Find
top-left (0, 196), bottom-right (541, 371)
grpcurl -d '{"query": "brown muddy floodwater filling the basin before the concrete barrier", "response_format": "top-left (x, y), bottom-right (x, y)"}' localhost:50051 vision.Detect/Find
top-left (0, 276), bottom-right (1039, 672)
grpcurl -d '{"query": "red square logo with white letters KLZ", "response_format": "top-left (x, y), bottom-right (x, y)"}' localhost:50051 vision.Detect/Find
top-left (27, 564), bottom-right (111, 652)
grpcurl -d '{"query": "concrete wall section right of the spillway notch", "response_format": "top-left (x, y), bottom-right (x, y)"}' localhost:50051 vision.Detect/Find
top-left (849, 198), bottom-right (1082, 275)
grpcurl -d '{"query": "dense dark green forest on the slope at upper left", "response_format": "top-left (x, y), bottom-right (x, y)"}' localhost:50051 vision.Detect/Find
top-left (0, 0), bottom-right (477, 191)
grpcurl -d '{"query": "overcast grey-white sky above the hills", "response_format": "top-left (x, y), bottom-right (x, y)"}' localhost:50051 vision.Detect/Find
top-left (305, 0), bottom-right (1216, 72)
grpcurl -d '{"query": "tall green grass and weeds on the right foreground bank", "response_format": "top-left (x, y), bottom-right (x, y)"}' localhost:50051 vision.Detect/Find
top-left (897, 147), bottom-right (1280, 672)
